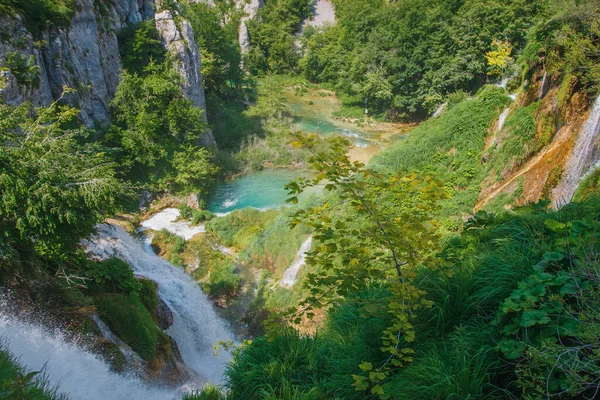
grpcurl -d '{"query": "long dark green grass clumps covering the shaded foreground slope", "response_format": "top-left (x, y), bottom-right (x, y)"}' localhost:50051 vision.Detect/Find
top-left (227, 200), bottom-right (600, 400)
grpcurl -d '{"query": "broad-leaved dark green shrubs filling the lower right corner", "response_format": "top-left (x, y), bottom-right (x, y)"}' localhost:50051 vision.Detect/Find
top-left (497, 210), bottom-right (600, 398)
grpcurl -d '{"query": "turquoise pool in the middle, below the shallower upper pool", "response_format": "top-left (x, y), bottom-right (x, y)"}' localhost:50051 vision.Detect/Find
top-left (207, 169), bottom-right (318, 214)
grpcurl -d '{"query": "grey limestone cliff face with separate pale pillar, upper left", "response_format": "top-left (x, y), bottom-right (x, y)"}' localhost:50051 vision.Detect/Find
top-left (0, 0), bottom-right (214, 145)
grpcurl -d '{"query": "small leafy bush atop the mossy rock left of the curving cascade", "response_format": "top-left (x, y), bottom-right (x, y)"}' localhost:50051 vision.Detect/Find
top-left (85, 257), bottom-right (143, 295)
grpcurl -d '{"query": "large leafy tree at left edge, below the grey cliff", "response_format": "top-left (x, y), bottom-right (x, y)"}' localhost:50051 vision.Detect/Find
top-left (0, 97), bottom-right (124, 258)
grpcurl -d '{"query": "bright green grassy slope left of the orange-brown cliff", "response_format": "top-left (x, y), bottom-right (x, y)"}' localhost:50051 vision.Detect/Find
top-left (370, 86), bottom-right (510, 230)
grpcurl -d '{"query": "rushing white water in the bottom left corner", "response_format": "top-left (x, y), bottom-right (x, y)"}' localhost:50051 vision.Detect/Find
top-left (0, 312), bottom-right (177, 400)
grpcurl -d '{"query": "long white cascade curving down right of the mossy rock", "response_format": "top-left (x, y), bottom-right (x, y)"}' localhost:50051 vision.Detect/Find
top-left (87, 224), bottom-right (233, 383)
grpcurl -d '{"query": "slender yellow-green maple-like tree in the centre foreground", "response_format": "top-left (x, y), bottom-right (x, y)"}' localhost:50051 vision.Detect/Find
top-left (278, 134), bottom-right (446, 395)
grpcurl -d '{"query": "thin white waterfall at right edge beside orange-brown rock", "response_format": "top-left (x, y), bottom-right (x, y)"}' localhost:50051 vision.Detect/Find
top-left (552, 96), bottom-right (600, 206)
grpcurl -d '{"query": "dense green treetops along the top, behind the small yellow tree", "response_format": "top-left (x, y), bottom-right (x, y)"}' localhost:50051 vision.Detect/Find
top-left (299, 0), bottom-right (544, 120)
